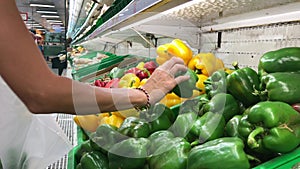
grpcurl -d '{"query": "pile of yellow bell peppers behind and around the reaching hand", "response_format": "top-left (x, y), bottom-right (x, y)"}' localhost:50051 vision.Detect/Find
top-left (156, 39), bottom-right (229, 107)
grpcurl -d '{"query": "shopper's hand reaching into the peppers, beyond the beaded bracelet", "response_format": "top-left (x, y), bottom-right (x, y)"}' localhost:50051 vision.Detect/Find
top-left (143, 57), bottom-right (189, 104)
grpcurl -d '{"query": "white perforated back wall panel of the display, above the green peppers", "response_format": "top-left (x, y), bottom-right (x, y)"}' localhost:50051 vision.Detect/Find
top-left (200, 22), bottom-right (300, 70)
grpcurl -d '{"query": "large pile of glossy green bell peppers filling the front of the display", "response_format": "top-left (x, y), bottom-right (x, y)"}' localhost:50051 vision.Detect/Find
top-left (75, 47), bottom-right (300, 169)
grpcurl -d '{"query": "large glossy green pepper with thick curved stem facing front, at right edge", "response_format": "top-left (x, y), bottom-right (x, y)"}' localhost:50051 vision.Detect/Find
top-left (241, 101), bottom-right (300, 153)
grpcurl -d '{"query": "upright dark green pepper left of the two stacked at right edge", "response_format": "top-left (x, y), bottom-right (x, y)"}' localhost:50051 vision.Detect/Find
top-left (227, 67), bottom-right (260, 107)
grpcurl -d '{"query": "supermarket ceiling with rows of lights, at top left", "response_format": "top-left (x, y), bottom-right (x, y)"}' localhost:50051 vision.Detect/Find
top-left (16, 0), bottom-right (68, 31)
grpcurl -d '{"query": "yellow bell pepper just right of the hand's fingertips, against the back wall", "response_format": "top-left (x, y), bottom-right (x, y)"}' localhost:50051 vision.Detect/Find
top-left (188, 53), bottom-right (224, 76)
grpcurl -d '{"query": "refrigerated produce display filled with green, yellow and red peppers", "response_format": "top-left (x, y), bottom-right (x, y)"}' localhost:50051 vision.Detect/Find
top-left (59, 0), bottom-right (300, 169)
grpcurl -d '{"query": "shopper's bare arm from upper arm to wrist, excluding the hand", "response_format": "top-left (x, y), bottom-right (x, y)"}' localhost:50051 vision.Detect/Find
top-left (0, 0), bottom-right (147, 114)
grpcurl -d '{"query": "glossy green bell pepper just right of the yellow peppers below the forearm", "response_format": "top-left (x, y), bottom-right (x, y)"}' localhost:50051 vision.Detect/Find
top-left (118, 117), bottom-right (150, 138)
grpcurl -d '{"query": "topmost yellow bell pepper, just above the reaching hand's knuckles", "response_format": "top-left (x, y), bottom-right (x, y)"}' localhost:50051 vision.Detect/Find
top-left (156, 39), bottom-right (193, 65)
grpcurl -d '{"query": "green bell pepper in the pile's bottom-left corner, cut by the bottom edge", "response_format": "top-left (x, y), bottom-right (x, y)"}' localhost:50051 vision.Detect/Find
top-left (79, 151), bottom-right (109, 169)
